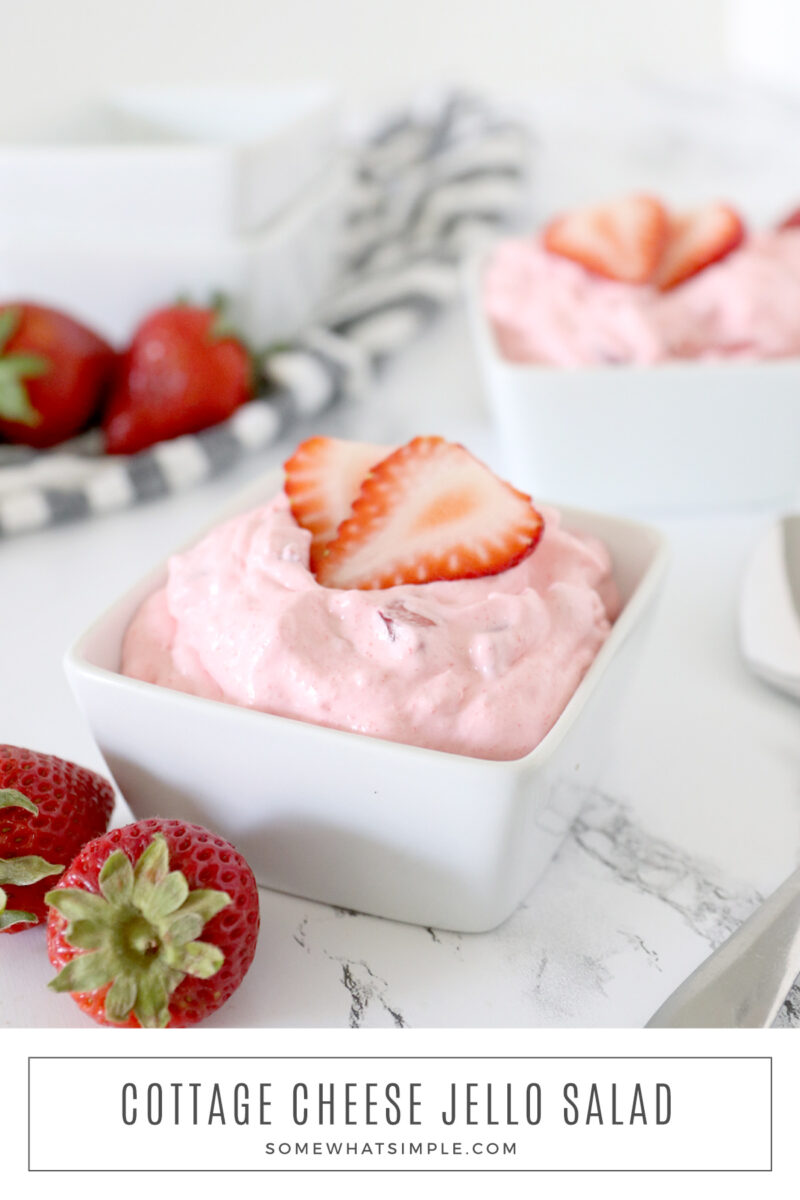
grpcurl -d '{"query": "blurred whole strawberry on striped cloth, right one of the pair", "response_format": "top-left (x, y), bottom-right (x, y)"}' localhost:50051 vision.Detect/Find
top-left (103, 305), bottom-right (253, 454)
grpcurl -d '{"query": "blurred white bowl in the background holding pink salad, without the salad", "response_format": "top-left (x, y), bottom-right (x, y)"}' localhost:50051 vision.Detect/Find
top-left (464, 256), bottom-right (800, 512)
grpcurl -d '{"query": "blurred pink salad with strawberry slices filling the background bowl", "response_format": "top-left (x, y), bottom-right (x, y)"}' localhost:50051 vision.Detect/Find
top-left (483, 194), bottom-right (800, 367)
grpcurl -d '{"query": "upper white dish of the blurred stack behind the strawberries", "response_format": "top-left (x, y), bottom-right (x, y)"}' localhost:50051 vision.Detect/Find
top-left (0, 84), bottom-right (338, 239)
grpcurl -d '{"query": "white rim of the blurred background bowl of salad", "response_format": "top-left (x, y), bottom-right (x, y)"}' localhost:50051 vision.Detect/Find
top-left (461, 242), bottom-right (800, 374)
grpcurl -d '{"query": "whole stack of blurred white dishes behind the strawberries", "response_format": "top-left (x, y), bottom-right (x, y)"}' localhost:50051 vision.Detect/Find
top-left (0, 85), bottom-right (348, 348)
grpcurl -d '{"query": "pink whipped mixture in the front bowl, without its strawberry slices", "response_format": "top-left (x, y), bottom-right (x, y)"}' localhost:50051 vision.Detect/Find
top-left (121, 496), bottom-right (619, 758)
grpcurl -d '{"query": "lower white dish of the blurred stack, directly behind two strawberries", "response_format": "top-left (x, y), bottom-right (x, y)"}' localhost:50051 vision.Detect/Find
top-left (0, 161), bottom-right (350, 350)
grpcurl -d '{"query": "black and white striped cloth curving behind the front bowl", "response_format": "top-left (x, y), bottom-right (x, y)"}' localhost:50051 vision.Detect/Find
top-left (0, 95), bottom-right (530, 538)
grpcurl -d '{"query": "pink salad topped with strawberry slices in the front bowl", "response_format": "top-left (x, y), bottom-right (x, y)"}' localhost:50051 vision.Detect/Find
top-left (121, 437), bottom-right (619, 758)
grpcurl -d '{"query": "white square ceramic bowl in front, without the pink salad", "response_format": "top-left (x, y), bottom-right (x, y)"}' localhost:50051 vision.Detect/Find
top-left (65, 475), bottom-right (667, 931)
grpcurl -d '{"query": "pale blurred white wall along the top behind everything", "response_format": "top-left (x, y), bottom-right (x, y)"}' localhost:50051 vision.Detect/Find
top-left (0, 0), bottom-right (800, 136)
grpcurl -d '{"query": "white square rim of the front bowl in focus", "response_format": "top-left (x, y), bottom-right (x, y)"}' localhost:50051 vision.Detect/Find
top-left (62, 468), bottom-right (669, 774)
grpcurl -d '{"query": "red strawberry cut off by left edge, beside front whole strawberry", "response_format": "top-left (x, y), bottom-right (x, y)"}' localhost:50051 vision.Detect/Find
top-left (0, 745), bottom-right (114, 934)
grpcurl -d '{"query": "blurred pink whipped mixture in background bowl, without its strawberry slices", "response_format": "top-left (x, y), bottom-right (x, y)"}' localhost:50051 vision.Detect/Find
top-left (483, 229), bottom-right (800, 367)
